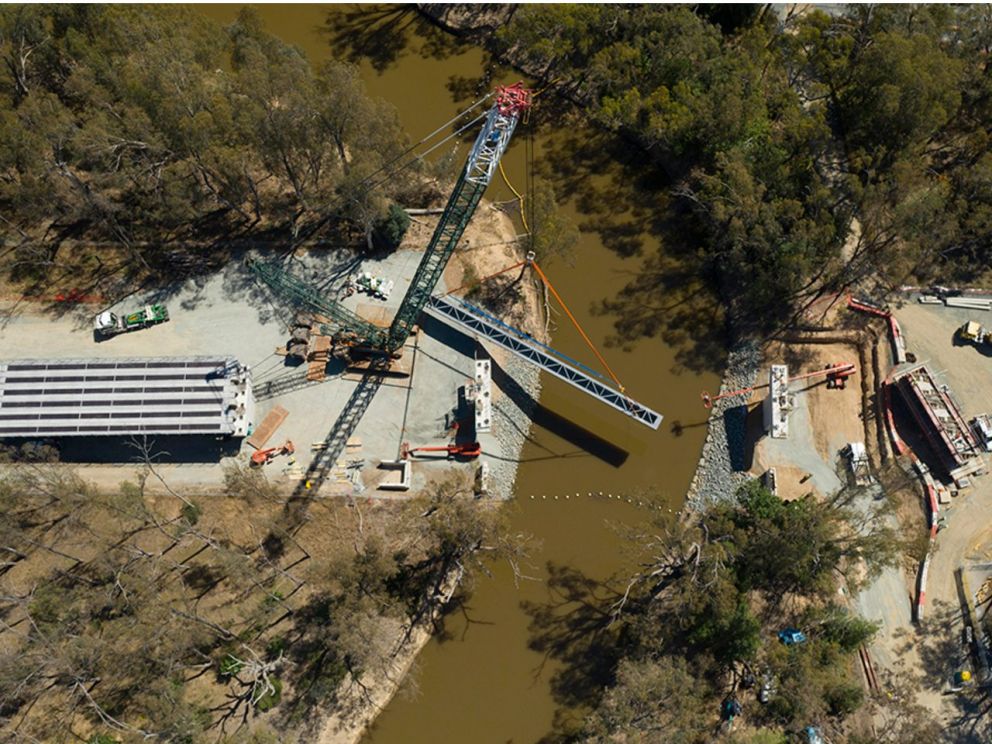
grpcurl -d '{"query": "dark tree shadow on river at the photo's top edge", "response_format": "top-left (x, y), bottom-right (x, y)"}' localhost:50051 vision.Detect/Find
top-left (319, 3), bottom-right (466, 72)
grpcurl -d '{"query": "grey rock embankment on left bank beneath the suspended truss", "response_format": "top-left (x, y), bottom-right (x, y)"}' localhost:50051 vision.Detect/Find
top-left (489, 354), bottom-right (541, 500)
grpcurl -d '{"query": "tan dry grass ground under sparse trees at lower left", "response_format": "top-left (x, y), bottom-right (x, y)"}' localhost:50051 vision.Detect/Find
top-left (0, 470), bottom-right (446, 741)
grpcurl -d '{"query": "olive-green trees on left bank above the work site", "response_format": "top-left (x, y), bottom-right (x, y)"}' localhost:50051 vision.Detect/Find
top-left (0, 5), bottom-right (424, 290)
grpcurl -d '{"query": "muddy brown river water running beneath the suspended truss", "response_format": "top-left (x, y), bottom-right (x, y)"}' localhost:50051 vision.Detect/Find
top-left (200, 5), bottom-right (719, 744)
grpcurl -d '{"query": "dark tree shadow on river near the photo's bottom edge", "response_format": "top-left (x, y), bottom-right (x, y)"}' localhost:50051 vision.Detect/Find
top-left (521, 562), bottom-right (620, 742)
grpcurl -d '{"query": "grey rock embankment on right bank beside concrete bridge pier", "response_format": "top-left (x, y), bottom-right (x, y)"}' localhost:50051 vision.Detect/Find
top-left (686, 341), bottom-right (761, 510)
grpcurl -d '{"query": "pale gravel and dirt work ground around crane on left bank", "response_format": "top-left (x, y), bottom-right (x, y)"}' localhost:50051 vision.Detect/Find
top-left (0, 203), bottom-right (540, 495)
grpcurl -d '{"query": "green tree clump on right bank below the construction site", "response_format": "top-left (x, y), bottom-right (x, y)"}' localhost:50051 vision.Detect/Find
top-left (571, 482), bottom-right (900, 744)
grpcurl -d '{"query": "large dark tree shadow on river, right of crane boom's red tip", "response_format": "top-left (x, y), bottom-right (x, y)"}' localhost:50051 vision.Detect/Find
top-left (537, 125), bottom-right (727, 372)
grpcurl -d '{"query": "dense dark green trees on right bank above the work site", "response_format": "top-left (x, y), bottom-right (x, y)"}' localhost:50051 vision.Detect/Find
top-left (493, 5), bottom-right (992, 340)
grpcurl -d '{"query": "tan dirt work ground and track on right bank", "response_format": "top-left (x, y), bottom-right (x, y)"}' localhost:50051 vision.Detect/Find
top-left (751, 322), bottom-right (992, 743)
